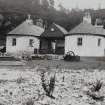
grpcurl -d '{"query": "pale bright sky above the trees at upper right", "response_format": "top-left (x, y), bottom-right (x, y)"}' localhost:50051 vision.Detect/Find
top-left (55, 0), bottom-right (105, 9)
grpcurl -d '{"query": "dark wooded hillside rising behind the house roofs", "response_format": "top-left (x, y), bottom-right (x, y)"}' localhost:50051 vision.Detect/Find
top-left (0, 0), bottom-right (105, 39)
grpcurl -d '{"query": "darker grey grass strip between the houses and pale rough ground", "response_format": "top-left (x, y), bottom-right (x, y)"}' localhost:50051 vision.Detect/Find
top-left (0, 57), bottom-right (105, 71)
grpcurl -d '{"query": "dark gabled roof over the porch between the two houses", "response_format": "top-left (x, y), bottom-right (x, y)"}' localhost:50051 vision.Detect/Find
top-left (41, 23), bottom-right (68, 38)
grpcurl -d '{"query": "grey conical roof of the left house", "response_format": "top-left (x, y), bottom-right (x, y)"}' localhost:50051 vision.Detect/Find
top-left (8, 19), bottom-right (44, 36)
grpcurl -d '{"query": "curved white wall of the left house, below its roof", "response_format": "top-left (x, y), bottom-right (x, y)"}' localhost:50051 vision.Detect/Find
top-left (6, 36), bottom-right (40, 54)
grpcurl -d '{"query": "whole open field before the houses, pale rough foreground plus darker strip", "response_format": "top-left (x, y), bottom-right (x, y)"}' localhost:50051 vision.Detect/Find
top-left (0, 60), bottom-right (105, 105)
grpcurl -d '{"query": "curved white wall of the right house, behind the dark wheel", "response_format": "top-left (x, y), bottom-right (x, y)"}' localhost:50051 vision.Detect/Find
top-left (65, 35), bottom-right (105, 56)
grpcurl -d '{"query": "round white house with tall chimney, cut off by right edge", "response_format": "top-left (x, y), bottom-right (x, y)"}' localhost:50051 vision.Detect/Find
top-left (65, 13), bottom-right (105, 57)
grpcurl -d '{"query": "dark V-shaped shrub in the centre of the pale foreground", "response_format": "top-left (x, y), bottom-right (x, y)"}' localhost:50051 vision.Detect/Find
top-left (41, 72), bottom-right (55, 99)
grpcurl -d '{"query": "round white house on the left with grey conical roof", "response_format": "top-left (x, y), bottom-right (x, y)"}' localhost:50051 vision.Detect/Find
top-left (6, 17), bottom-right (44, 55)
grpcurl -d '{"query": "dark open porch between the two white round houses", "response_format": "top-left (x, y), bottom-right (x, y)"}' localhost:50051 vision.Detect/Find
top-left (39, 39), bottom-right (64, 55)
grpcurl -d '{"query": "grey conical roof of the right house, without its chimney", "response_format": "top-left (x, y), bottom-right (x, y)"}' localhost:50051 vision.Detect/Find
top-left (69, 21), bottom-right (105, 36)
